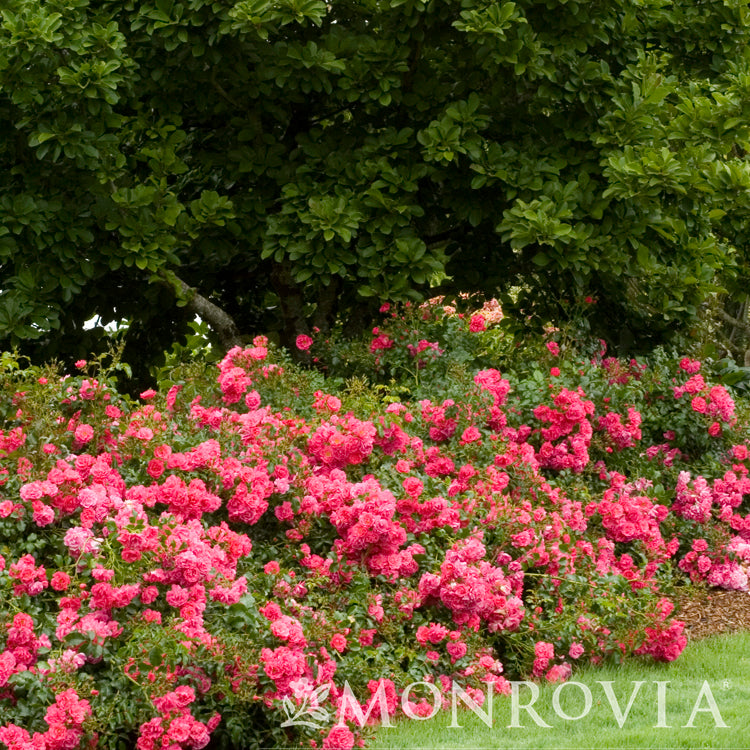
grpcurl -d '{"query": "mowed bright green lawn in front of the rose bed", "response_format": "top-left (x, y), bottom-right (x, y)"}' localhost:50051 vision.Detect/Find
top-left (368, 634), bottom-right (750, 750)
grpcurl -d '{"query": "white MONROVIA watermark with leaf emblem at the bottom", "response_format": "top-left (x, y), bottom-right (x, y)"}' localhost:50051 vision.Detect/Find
top-left (281, 680), bottom-right (729, 729)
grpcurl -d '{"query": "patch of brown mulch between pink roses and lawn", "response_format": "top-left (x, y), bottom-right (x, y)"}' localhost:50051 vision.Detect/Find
top-left (674, 589), bottom-right (750, 641)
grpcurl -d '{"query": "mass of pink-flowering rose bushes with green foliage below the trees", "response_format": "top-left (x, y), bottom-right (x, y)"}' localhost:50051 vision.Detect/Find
top-left (0, 305), bottom-right (750, 750)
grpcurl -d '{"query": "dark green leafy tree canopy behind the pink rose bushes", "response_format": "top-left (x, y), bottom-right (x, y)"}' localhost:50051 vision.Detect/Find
top-left (0, 0), bottom-right (750, 368)
